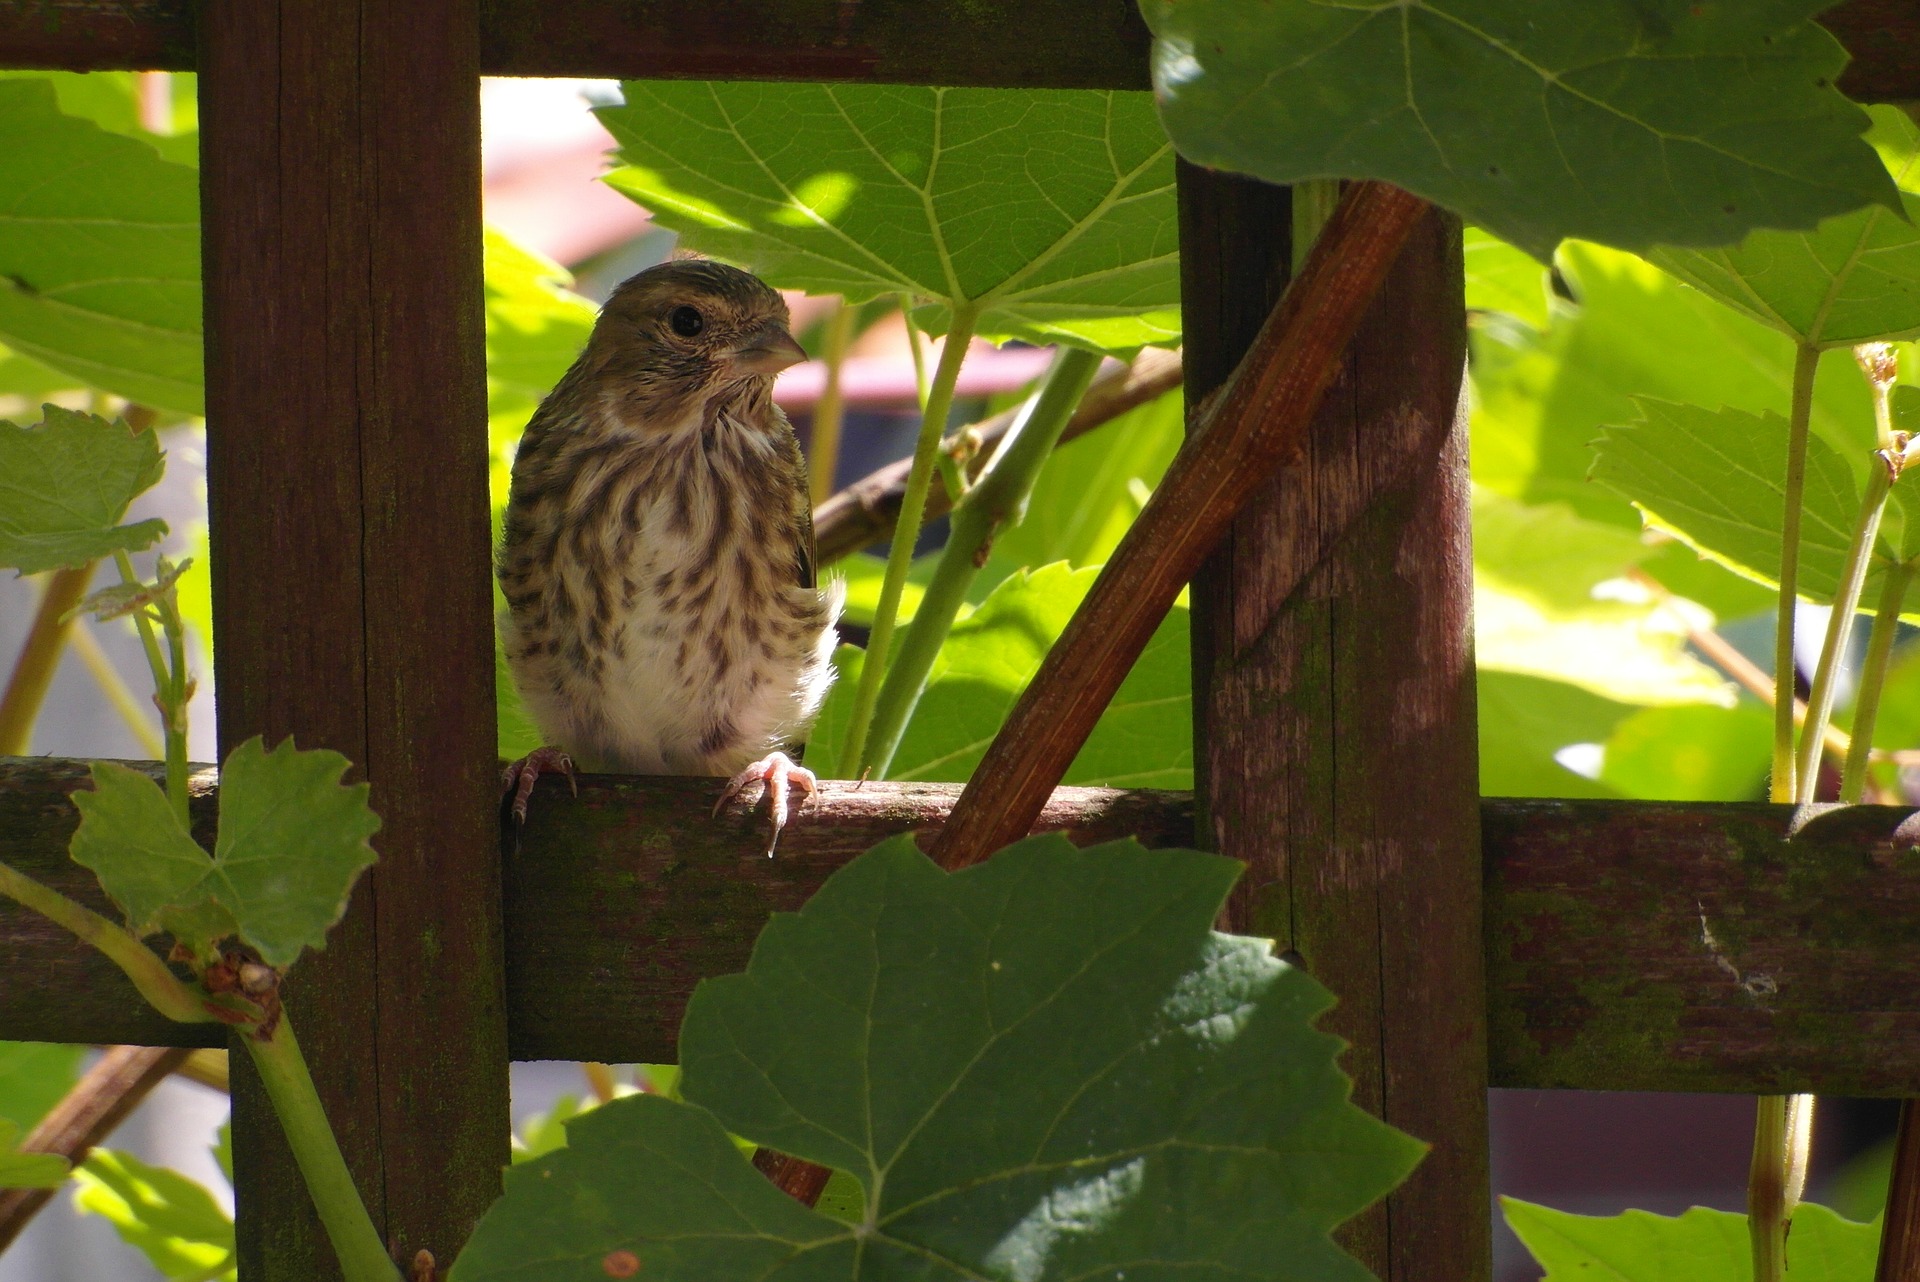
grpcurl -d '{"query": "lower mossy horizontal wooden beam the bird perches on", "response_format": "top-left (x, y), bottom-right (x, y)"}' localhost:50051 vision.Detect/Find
top-left (0, 758), bottom-right (1920, 1096)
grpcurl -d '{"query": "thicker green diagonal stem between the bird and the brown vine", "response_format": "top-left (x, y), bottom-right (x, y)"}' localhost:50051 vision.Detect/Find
top-left (868, 347), bottom-right (1100, 779)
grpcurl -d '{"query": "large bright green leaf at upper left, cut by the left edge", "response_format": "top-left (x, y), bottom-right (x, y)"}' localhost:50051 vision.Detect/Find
top-left (0, 79), bottom-right (204, 415)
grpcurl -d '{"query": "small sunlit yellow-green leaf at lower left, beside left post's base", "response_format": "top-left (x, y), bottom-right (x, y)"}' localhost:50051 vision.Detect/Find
top-left (73, 1148), bottom-right (238, 1282)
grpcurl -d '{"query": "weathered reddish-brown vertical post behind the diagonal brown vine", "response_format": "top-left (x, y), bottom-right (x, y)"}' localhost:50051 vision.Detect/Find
top-left (1179, 165), bottom-right (1490, 1282)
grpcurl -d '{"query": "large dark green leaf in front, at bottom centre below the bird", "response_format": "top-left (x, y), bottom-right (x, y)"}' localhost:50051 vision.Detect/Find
top-left (453, 835), bottom-right (1423, 1282)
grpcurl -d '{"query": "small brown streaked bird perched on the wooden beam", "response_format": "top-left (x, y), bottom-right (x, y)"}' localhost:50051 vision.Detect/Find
top-left (495, 259), bottom-right (843, 854)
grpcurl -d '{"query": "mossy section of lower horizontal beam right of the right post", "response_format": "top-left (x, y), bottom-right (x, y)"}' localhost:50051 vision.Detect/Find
top-left (1482, 802), bottom-right (1920, 1096)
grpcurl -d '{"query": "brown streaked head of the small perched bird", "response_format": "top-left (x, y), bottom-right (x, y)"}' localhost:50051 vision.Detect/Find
top-left (588, 259), bottom-right (806, 426)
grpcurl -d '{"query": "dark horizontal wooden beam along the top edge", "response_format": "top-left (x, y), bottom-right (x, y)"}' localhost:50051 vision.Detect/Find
top-left (0, 0), bottom-right (1920, 102)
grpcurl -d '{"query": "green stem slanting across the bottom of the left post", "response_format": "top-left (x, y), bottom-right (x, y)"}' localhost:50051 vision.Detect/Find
top-left (240, 1011), bottom-right (401, 1282)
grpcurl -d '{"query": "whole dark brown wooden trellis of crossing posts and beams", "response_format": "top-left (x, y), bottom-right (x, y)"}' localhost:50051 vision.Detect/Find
top-left (0, 0), bottom-right (1920, 1282)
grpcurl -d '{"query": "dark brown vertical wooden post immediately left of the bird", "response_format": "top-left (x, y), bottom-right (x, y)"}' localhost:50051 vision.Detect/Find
top-left (200, 0), bottom-right (507, 1282)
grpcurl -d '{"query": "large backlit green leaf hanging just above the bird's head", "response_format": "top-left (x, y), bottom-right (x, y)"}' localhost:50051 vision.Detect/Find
top-left (599, 81), bottom-right (1181, 353)
